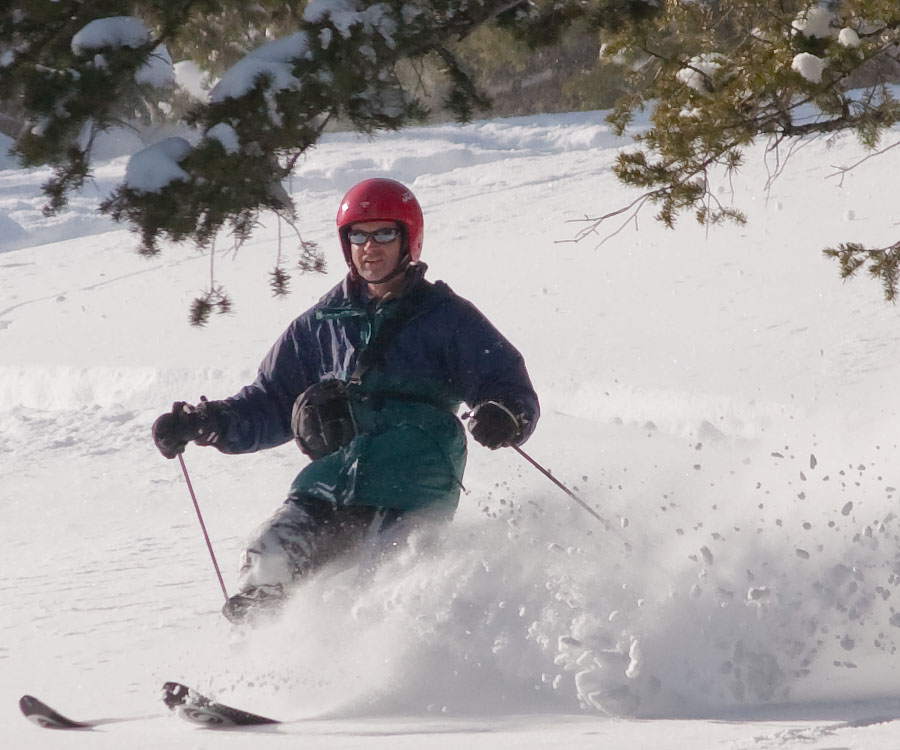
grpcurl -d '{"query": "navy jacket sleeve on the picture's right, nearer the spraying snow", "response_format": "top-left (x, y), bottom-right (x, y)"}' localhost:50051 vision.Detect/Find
top-left (449, 298), bottom-right (541, 444)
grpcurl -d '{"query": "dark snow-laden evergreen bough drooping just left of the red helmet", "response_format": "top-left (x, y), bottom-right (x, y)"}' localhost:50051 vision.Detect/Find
top-left (102, 0), bottom-right (515, 254)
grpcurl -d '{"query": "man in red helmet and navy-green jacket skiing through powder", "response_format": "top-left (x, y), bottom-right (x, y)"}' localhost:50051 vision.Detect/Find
top-left (153, 179), bottom-right (540, 622)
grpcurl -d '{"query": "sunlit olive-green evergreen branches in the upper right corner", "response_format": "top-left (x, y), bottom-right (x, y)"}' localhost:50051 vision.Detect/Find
top-left (585, 0), bottom-right (900, 300)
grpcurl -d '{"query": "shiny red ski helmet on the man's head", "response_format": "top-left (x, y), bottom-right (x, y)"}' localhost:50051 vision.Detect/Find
top-left (337, 177), bottom-right (425, 265)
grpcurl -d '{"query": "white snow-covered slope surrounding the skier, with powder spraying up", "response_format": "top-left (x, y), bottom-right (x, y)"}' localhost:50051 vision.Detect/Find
top-left (0, 113), bottom-right (900, 750)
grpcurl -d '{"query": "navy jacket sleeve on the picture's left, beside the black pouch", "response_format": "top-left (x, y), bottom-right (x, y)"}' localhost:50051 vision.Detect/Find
top-left (216, 313), bottom-right (318, 453)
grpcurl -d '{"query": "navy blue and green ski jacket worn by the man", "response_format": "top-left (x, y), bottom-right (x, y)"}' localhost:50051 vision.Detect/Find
top-left (217, 263), bottom-right (540, 507)
